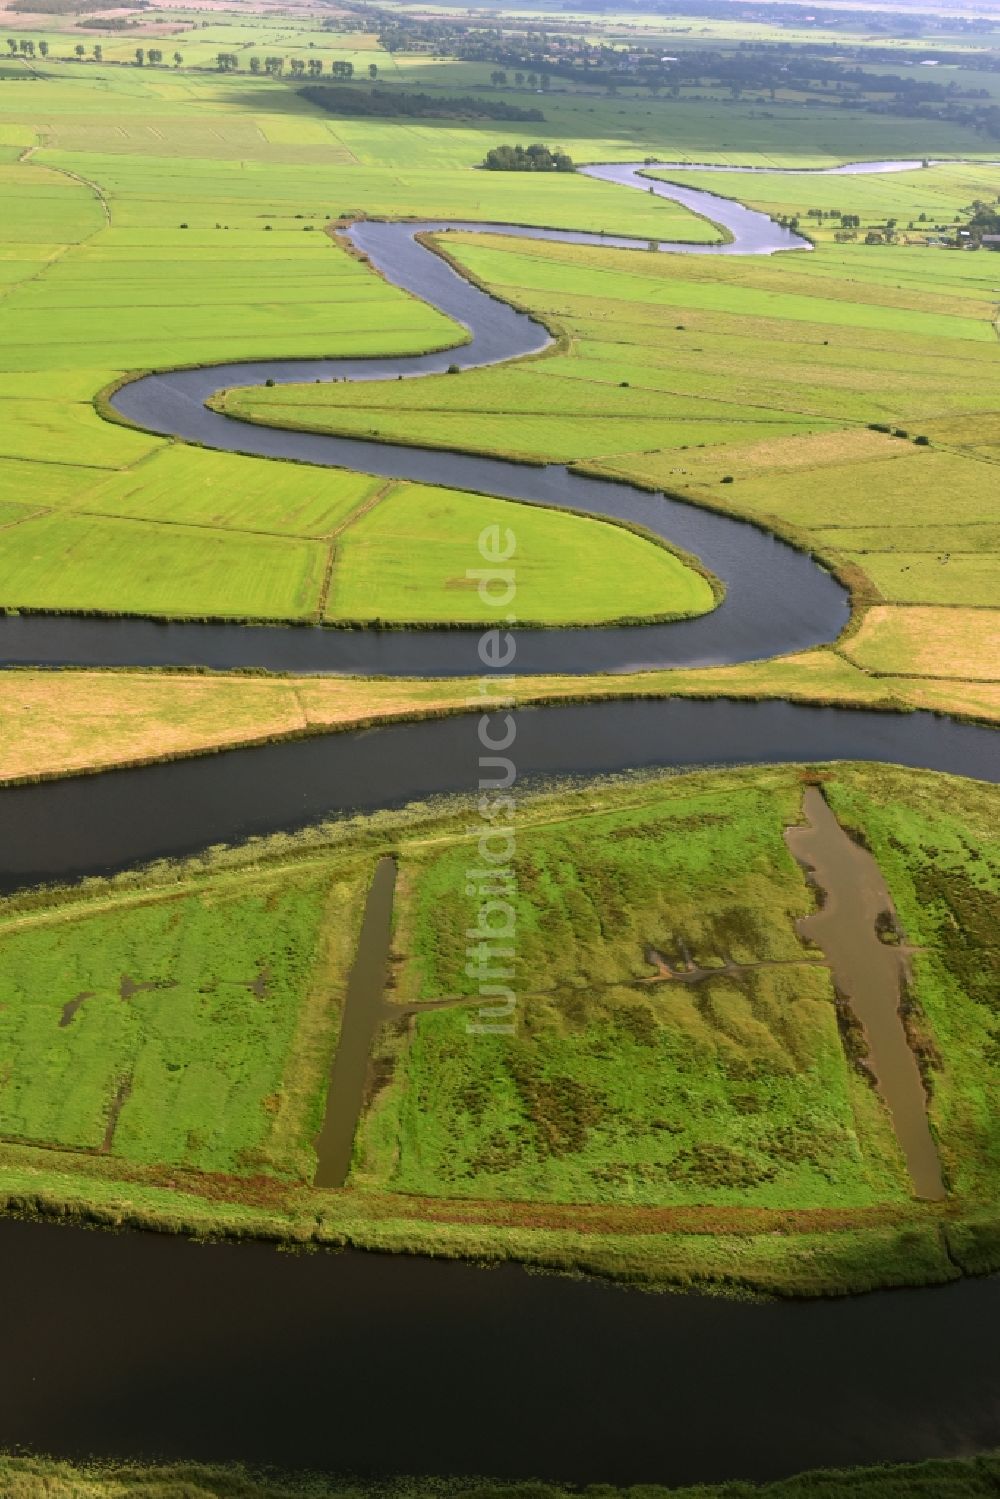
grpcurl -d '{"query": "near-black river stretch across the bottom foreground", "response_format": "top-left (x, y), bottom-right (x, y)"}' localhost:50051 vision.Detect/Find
top-left (0, 1222), bottom-right (1000, 1483)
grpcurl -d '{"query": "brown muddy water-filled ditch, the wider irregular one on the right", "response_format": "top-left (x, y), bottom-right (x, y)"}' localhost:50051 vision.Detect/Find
top-left (786, 785), bottom-right (946, 1201)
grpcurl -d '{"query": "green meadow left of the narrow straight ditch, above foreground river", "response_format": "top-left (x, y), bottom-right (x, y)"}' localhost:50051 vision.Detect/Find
top-left (0, 869), bottom-right (371, 1177)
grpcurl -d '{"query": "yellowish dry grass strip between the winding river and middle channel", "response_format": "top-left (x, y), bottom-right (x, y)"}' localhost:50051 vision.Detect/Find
top-left (0, 659), bottom-right (1000, 784)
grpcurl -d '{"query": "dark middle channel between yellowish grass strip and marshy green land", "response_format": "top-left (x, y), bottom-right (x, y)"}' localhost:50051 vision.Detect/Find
top-left (0, 699), bottom-right (1000, 890)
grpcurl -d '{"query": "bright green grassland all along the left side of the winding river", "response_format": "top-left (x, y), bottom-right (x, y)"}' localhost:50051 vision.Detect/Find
top-left (0, 58), bottom-right (749, 624)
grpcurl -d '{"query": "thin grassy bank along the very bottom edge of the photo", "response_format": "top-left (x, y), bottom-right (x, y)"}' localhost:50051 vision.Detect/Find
top-left (0, 1454), bottom-right (1000, 1499)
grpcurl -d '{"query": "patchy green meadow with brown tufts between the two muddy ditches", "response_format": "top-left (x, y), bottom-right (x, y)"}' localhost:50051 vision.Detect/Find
top-left (355, 772), bottom-right (909, 1208)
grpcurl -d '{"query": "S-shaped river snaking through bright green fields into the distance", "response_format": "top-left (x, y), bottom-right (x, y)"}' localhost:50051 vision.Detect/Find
top-left (0, 162), bottom-right (947, 676)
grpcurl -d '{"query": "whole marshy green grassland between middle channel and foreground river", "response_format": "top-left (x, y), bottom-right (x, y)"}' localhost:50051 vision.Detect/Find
top-left (0, 766), bottom-right (1000, 1292)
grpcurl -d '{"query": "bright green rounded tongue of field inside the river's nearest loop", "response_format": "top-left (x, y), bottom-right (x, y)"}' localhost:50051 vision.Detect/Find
top-left (0, 445), bottom-right (715, 625)
